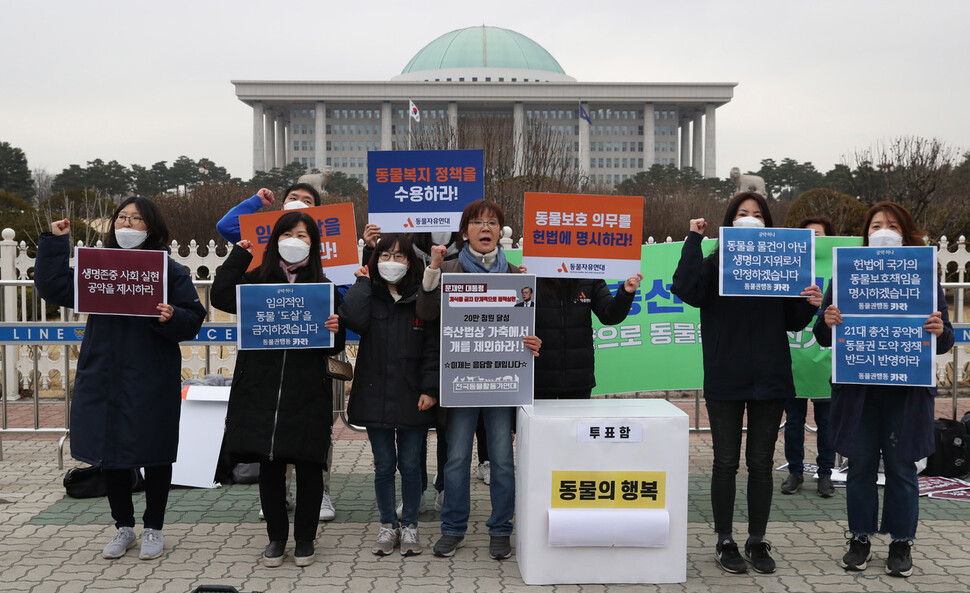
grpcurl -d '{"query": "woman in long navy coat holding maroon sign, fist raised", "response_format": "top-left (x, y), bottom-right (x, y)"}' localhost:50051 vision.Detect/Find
top-left (34, 197), bottom-right (205, 560)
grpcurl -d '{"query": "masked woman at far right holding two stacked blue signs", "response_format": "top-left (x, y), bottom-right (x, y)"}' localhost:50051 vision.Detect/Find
top-left (813, 202), bottom-right (954, 577)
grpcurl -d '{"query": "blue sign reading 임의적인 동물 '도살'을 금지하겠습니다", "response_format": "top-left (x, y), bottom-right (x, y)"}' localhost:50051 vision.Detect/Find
top-left (236, 283), bottom-right (334, 350)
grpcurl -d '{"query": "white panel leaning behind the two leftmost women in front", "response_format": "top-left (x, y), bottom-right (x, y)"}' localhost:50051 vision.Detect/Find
top-left (172, 385), bottom-right (229, 488)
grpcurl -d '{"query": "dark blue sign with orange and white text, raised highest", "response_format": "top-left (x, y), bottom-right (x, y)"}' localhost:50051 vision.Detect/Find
top-left (367, 150), bottom-right (485, 233)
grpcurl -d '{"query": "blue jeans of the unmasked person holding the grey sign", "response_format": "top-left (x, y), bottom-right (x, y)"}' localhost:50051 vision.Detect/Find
top-left (441, 408), bottom-right (515, 536)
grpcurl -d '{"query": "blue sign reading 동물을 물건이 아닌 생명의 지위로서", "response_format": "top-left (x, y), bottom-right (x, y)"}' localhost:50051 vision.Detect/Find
top-left (718, 227), bottom-right (815, 297)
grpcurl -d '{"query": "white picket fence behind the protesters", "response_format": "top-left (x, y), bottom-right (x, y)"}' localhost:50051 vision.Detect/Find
top-left (0, 227), bottom-right (970, 400)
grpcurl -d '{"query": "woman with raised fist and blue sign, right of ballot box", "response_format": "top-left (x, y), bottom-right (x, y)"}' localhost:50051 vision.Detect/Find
top-left (671, 193), bottom-right (822, 573)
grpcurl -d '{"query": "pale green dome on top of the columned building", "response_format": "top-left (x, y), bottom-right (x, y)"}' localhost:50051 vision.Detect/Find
top-left (401, 26), bottom-right (566, 79)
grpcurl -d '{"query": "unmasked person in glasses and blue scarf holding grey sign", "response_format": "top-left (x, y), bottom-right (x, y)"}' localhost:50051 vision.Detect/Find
top-left (417, 200), bottom-right (541, 560)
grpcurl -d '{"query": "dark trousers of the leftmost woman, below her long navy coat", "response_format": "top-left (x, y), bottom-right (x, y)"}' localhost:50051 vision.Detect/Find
top-left (101, 464), bottom-right (172, 530)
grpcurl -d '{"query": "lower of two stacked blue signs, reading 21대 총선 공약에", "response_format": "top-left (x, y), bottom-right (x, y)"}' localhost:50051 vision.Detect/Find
top-left (832, 315), bottom-right (936, 387)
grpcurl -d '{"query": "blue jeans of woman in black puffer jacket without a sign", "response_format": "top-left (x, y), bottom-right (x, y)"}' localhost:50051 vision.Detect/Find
top-left (367, 428), bottom-right (428, 528)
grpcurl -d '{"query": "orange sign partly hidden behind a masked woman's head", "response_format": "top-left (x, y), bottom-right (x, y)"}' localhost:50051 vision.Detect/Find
top-left (239, 202), bottom-right (360, 284)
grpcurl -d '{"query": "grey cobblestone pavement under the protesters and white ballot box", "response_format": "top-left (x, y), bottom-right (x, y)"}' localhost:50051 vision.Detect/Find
top-left (0, 402), bottom-right (970, 593)
